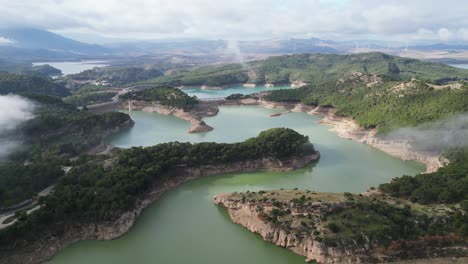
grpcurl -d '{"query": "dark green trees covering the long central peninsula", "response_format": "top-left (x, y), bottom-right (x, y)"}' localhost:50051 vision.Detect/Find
top-left (0, 128), bottom-right (315, 244)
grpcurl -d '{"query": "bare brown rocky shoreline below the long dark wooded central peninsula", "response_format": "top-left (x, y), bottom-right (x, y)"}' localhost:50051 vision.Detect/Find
top-left (0, 151), bottom-right (320, 264)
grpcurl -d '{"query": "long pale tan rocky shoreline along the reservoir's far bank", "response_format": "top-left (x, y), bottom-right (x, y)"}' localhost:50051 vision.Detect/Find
top-left (124, 98), bottom-right (442, 173)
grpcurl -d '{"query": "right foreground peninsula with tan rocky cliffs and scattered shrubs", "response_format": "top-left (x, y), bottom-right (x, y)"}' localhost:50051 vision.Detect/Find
top-left (213, 189), bottom-right (468, 264)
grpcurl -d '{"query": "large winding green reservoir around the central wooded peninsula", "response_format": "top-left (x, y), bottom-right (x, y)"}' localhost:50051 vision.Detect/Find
top-left (50, 106), bottom-right (424, 264)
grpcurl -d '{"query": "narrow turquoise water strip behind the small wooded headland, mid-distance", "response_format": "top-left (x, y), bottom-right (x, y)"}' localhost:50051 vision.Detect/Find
top-left (182, 86), bottom-right (291, 99)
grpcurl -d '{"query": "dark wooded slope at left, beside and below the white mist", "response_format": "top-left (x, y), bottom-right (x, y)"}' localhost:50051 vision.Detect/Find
top-left (0, 95), bottom-right (132, 208)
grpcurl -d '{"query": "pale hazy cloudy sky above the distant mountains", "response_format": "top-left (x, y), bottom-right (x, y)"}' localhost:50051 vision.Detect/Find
top-left (0, 0), bottom-right (468, 42)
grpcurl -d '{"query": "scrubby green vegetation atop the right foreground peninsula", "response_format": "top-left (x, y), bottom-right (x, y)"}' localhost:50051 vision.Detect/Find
top-left (221, 188), bottom-right (468, 258)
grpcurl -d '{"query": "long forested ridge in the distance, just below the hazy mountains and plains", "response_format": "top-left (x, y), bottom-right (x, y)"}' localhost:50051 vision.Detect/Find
top-left (141, 52), bottom-right (468, 86)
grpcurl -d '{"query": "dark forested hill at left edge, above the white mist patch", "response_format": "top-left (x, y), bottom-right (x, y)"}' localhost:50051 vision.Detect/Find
top-left (0, 72), bottom-right (70, 97)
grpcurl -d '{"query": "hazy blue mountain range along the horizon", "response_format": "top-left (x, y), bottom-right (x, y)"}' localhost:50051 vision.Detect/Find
top-left (0, 28), bottom-right (468, 62)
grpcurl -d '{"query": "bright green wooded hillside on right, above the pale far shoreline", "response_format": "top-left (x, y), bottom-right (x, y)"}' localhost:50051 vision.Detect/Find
top-left (265, 77), bottom-right (468, 133)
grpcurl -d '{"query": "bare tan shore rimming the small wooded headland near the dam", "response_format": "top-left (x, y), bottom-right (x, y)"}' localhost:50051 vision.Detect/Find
top-left (124, 101), bottom-right (219, 133)
